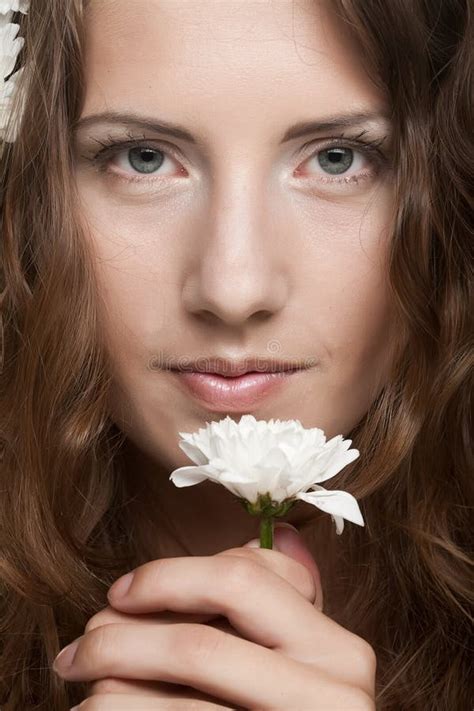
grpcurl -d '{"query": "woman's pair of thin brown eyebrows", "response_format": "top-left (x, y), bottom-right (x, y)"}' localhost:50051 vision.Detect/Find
top-left (73, 111), bottom-right (389, 144)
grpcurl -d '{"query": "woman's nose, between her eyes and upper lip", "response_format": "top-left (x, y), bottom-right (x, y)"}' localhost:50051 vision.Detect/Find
top-left (183, 171), bottom-right (288, 327)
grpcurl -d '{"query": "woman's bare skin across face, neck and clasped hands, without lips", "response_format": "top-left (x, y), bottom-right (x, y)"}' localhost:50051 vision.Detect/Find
top-left (61, 0), bottom-right (394, 711)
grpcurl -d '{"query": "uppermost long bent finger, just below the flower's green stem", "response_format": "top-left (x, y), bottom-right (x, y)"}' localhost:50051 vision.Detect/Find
top-left (108, 549), bottom-right (344, 661)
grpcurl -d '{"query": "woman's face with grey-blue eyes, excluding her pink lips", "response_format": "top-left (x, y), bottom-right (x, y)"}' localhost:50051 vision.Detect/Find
top-left (76, 0), bottom-right (393, 468)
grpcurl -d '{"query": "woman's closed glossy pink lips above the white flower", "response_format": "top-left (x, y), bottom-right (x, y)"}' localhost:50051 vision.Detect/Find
top-left (171, 369), bottom-right (303, 412)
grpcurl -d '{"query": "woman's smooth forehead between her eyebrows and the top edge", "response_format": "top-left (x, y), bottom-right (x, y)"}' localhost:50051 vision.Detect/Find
top-left (84, 0), bottom-right (384, 136)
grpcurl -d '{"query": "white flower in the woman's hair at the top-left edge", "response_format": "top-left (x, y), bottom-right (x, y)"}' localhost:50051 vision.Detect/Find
top-left (0, 0), bottom-right (29, 142)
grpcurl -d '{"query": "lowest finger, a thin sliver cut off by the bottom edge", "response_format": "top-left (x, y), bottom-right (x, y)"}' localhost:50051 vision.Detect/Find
top-left (75, 694), bottom-right (236, 711)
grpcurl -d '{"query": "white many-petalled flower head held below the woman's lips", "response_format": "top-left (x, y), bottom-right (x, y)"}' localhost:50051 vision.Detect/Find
top-left (170, 415), bottom-right (364, 534)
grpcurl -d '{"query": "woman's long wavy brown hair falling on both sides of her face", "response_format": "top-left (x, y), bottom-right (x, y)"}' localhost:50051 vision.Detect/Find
top-left (0, 0), bottom-right (474, 711)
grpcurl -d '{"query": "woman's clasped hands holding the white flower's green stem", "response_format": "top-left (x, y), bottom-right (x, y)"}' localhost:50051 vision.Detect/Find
top-left (52, 527), bottom-right (376, 711)
